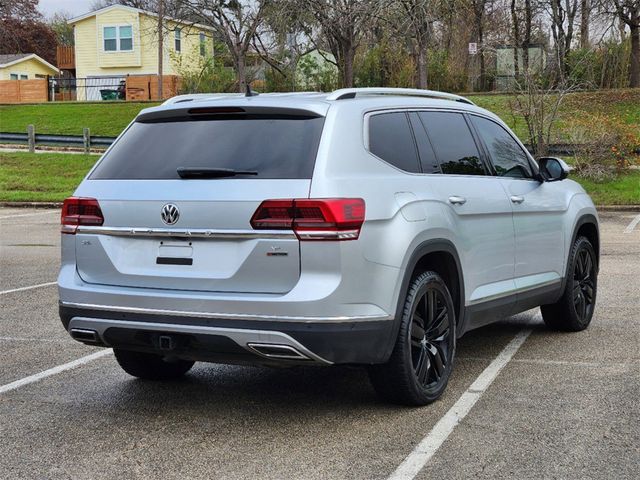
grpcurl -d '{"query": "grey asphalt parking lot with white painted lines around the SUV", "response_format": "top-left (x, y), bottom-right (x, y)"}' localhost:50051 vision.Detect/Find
top-left (0, 208), bottom-right (640, 479)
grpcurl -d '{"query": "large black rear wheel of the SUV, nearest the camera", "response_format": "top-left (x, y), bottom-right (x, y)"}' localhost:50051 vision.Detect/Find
top-left (369, 271), bottom-right (456, 406)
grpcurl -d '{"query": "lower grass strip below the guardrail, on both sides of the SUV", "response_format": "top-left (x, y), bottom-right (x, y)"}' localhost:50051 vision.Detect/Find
top-left (0, 152), bottom-right (640, 205)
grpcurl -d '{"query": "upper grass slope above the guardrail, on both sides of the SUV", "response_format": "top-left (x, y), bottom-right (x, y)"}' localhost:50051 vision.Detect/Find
top-left (0, 88), bottom-right (640, 142)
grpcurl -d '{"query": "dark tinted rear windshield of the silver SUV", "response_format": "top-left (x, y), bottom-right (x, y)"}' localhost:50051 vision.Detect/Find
top-left (90, 114), bottom-right (324, 180)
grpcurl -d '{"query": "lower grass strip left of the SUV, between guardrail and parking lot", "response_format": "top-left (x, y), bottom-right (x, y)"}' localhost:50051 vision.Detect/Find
top-left (0, 152), bottom-right (100, 202)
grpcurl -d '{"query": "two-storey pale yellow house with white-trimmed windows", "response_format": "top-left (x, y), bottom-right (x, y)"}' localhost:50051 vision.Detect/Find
top-left (68, 5), bottom-right (213, 100)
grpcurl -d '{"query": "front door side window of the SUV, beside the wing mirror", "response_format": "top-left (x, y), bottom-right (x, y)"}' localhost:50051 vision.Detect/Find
top-left (471, 115), bottom-right (531, 178)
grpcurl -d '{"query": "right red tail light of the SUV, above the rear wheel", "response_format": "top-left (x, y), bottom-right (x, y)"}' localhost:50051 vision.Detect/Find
top-left (251, 198), bottom-right (365, 240)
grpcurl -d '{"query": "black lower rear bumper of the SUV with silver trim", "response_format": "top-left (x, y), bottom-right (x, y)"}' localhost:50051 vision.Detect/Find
top-left (60, 302), bottom-right (393, 365)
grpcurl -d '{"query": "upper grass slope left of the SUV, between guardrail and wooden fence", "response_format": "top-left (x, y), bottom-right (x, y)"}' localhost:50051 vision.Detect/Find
top-left (0, 102), bottom-right (157, 137)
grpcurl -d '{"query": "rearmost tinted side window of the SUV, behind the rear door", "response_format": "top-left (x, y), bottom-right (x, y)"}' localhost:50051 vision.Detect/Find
top-left (369, 112), bottom-right (420, 172)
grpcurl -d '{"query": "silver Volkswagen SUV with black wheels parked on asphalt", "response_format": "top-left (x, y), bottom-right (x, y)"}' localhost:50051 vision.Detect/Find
top-left (58, 88), bottom-right (599, 405)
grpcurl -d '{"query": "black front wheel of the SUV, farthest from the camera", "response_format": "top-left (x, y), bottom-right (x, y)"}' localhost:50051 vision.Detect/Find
top-left (540, 237), bottom-right (598, 332)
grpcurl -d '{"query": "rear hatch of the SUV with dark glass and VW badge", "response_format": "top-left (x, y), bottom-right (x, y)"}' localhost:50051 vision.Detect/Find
top-left (71, 108), bottom-right (324, 293)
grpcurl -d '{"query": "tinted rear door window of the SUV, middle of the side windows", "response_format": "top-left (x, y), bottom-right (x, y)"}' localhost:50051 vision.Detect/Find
top-left (418, 112), bottom-right (485, 175)
